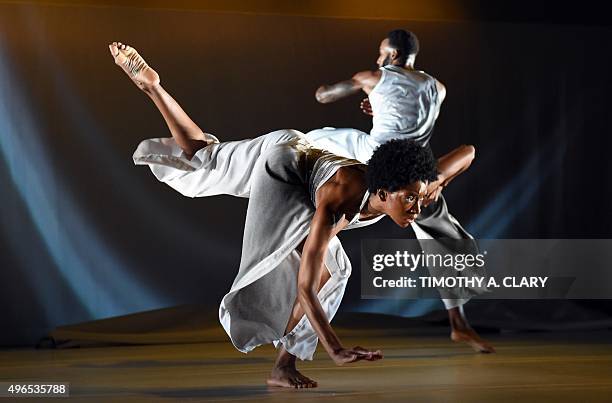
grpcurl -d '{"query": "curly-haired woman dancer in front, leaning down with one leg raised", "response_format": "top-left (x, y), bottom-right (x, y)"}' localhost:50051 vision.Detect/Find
top-left (109, 43), bottom-right (482, 388)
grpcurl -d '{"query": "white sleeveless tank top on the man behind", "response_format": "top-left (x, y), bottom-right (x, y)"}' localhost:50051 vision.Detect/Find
top-left (369, 65), bottom-right (440, 146)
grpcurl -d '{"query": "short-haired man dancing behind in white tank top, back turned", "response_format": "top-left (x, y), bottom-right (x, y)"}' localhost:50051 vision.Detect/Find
top-left (306, 30), bottom-right (495, 353)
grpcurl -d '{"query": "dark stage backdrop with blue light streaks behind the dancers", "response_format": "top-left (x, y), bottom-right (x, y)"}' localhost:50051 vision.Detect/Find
top-left (0, 4), bottom-right (612, 344)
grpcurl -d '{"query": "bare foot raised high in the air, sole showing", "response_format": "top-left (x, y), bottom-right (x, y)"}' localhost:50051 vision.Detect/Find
top-left (108, 42), bottom-right (159, 91)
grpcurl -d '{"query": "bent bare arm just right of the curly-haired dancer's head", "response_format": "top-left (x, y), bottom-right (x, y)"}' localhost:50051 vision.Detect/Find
top-left (423, 144), bottom-right (476, 206)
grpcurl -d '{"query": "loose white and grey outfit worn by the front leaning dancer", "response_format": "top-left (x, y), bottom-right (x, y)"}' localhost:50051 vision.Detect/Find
top-left (133, 130), bottom-right (383, 360)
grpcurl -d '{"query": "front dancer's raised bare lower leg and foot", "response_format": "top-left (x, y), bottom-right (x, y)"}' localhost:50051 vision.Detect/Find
top-left (108, 42), bottom-right (215, 159)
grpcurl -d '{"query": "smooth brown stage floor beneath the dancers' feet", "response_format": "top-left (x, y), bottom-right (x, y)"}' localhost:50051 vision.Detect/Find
top-left (0, 329), bottom-right (612, 403)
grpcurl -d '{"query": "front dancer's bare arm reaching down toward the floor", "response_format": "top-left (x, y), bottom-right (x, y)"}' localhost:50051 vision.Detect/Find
top-left (298, 205), bottom-right (382, 365)
